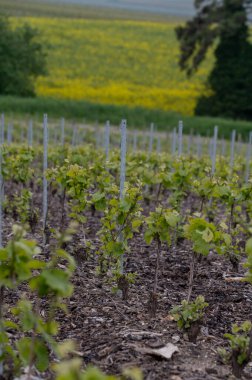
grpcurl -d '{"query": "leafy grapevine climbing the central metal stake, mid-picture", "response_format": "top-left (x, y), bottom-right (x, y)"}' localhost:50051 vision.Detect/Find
top-left (92, 183), bottom-right (142, 299)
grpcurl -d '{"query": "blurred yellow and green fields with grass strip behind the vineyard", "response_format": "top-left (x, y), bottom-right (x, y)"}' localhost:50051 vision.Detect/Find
top-left (0, 0), bottom-right (250, 136)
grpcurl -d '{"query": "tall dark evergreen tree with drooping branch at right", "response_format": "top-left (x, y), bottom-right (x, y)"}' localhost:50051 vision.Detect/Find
top-left (176, 0), bottom-right (252, 119)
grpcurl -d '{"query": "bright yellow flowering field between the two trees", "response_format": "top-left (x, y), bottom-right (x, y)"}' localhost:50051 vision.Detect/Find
top-left (12, 17), bottom-right (212, 115)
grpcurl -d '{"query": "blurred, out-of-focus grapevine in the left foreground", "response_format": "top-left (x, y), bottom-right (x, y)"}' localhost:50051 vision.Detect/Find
top-left (0, 225), bottom-right (75, 379)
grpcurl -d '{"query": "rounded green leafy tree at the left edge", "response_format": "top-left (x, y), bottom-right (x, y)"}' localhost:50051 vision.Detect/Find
top-left (0, 16), bottom-right (46, 96)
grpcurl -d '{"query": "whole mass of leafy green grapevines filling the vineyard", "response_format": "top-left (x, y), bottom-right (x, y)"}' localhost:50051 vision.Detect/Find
top-left (0, 117), bottom-right (252, 380)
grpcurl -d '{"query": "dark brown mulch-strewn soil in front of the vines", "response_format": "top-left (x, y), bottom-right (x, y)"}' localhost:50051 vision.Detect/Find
top-left (2, 189), bottom-right (252, 380)
